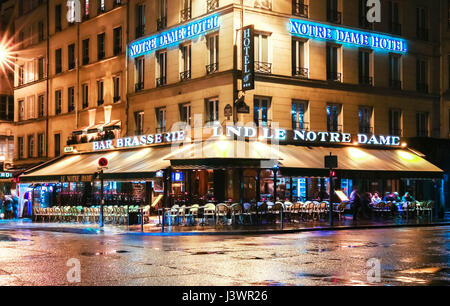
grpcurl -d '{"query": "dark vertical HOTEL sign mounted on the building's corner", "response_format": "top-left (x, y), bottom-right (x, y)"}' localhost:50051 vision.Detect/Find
top-left (242, 25), bottom-right (255, 91)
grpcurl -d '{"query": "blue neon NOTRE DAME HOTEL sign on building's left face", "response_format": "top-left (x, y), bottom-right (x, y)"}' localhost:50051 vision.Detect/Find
top-left (129, 14), bottom-right (219, 57)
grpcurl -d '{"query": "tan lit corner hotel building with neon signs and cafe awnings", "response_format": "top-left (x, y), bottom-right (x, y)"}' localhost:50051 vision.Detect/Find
top-left (15, 0), bottom-right (448, 215)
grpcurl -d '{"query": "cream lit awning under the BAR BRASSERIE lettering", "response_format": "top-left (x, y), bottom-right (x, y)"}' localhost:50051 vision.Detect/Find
top-left (20, 146), bottom-right (171, 182)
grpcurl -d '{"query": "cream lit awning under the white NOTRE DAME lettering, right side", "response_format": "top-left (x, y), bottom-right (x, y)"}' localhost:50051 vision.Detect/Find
top-left (279, 145), bottom-right (443, 178)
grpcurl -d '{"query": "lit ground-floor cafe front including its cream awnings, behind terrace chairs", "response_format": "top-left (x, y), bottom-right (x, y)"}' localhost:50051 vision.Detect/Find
top-left (19, 129), bottom-right (442, 222)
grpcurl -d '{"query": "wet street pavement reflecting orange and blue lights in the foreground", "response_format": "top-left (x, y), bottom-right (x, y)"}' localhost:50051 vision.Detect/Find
top-left (0, 227), bottom-right (450, 286)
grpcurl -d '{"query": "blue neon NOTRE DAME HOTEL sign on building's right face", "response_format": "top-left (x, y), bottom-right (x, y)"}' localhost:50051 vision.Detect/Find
top-left (289, 19), bottom-right (408, 53)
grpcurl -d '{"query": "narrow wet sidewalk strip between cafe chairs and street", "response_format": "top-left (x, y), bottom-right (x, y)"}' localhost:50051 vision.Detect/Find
top-left (0, 214), bottom-right (450, 236)
